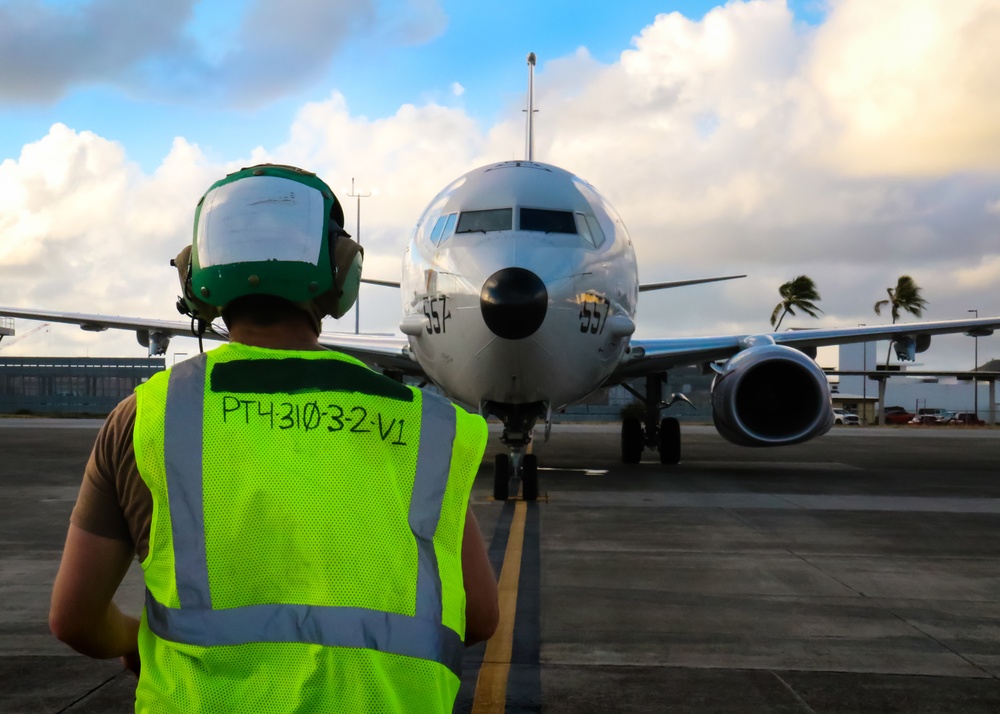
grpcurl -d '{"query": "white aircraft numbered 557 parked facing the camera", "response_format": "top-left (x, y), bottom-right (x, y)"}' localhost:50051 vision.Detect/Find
top-left (0, 54), bottom-right (1000, 500)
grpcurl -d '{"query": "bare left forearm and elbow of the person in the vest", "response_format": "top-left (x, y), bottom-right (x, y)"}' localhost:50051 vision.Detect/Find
top-left (49, 525), bottom-right (139, 659)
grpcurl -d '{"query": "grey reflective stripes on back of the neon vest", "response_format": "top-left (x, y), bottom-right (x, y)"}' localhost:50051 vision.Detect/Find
top-left (146, 354), bottom-right (465, 676)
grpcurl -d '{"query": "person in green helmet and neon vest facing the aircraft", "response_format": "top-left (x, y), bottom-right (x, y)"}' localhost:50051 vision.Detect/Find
top-left (50, 164), bottom-right (498, 714)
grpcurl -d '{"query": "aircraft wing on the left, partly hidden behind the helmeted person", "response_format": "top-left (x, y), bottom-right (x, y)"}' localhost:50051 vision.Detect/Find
top-left (0, 307), bottom-right (423, 376)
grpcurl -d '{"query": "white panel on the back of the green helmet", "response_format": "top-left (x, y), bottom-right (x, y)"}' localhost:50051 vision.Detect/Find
top-left (195, 176), bottom-right (325, 268)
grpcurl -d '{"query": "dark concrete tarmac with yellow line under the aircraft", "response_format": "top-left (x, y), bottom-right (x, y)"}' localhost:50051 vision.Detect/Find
top-left (0, 419), bottom-right (1000, 714)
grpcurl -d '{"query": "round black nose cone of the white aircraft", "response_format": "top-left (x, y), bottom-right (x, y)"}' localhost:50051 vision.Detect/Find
top-left (479, 268), bottom-right (549, 340)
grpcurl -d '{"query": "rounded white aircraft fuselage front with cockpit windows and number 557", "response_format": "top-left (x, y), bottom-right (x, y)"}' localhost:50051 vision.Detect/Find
top-left (401, 161), bottom-right (638, 409)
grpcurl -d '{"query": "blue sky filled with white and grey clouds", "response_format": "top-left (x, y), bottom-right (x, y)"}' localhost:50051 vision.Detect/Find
top-left (0, 0), bottom-right (1000, 369)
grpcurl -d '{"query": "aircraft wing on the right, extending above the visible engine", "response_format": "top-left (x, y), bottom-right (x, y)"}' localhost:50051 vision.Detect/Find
top-left (608, 317), bottom-right (1000, 384)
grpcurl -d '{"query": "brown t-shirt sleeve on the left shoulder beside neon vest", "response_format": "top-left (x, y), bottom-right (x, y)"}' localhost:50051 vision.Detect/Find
top-left (70, 394), bottom-right (153, 560)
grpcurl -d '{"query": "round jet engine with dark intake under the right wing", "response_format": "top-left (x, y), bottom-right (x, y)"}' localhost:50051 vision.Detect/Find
top-left (712, 337), bottom-right (833, 446)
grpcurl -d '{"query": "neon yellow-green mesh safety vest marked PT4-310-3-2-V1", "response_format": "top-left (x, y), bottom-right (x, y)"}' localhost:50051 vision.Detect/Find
top-left (133, 343), bottom-right (486, 714)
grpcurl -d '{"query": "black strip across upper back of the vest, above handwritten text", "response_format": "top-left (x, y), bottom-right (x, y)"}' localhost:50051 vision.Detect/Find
top-left (210, 357), bottom-right (413, 402)
